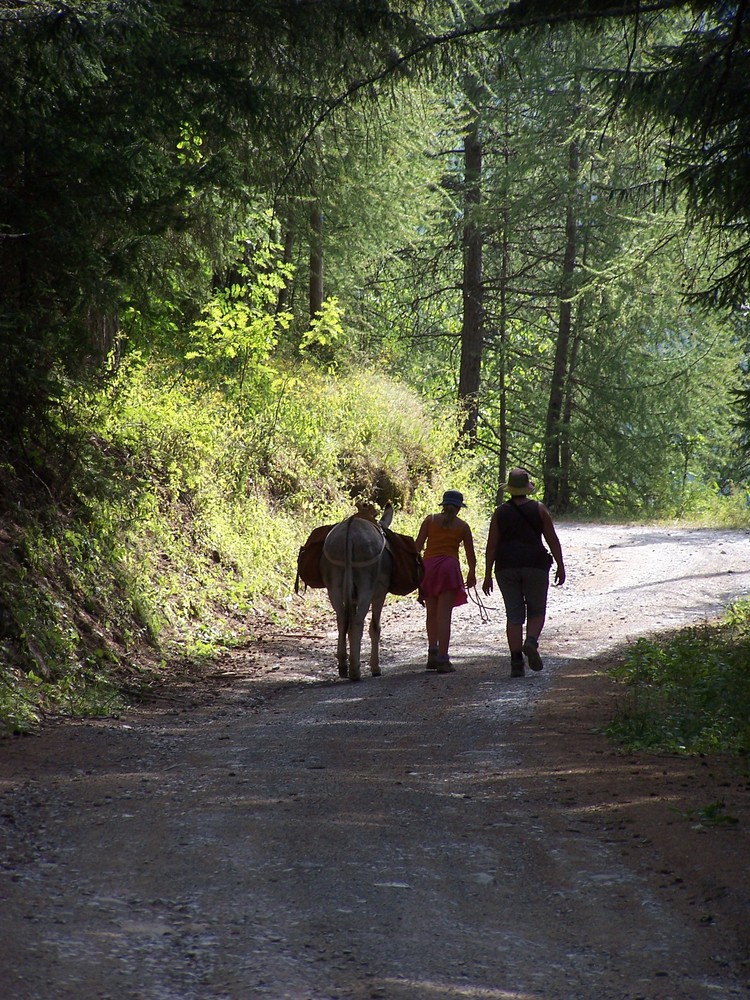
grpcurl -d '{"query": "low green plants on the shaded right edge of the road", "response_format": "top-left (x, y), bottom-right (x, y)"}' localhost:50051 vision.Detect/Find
top-left (605, 599), bottom-right (750, 756)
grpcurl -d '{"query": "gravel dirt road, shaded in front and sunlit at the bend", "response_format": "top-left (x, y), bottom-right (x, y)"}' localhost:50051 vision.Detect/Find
top-left (0, 525), bottom-right (750, 1000)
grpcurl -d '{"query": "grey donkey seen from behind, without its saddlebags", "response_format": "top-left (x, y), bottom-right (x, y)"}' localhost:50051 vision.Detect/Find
top-left (320, 504), bottom-right (393, 681)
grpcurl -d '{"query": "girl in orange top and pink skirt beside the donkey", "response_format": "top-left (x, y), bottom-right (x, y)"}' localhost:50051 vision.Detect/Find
top-left (417, 490), bottom-right (477, 674)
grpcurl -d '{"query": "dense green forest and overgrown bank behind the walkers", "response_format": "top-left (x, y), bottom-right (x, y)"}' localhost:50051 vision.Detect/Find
top-left (0, 0), bottom-right (750, 727)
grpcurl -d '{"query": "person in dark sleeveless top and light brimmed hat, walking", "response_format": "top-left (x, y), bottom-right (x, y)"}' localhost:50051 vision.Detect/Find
top-left (482, 469), bottom-right (565, 677)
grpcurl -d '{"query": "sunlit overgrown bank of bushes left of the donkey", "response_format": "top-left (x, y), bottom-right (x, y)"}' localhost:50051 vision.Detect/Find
top-left (0, 346), bottom-right (470, 730)
